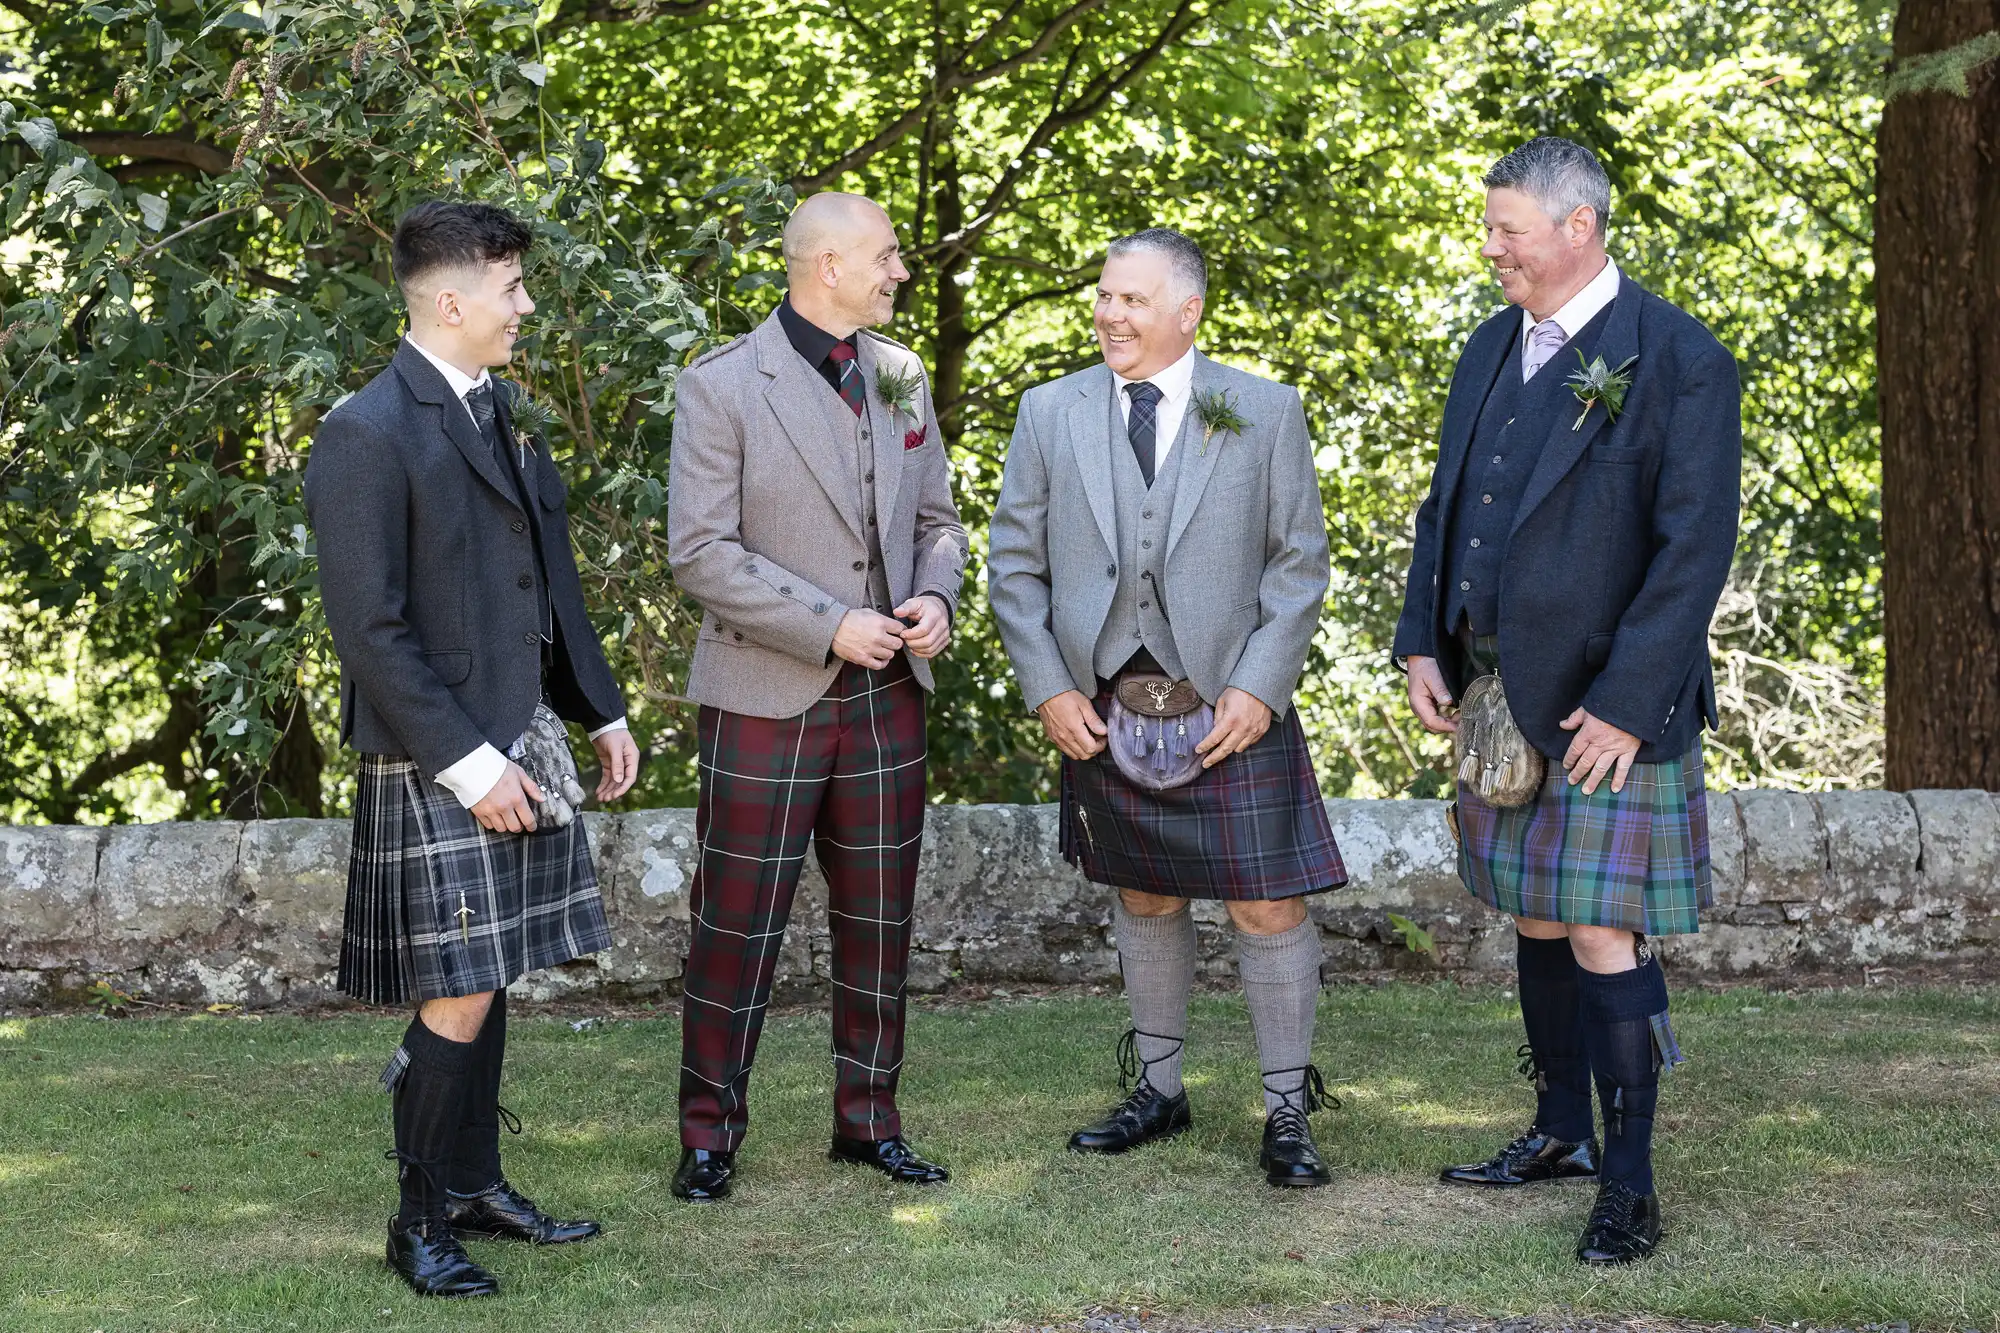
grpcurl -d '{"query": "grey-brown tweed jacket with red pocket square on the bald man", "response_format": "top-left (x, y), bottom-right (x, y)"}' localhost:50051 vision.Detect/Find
top-left (666, 312), bottom-right (966, 717)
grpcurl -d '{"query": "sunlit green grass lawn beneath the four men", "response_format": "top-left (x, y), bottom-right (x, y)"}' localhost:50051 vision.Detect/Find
top-left (0, 985), bottom-right (2000, 1333)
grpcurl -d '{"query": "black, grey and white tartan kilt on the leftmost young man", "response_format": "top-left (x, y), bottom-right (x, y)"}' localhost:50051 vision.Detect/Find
top-left (340, 755), bottom-right (612, 1005)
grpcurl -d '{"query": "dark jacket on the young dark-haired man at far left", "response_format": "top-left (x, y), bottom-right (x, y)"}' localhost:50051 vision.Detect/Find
top-left (306, 342), bottom-right (624, 779)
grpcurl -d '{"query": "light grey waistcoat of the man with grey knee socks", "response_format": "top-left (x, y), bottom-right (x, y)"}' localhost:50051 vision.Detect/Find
top-left (1092, 398), bottom-right (1194, 681)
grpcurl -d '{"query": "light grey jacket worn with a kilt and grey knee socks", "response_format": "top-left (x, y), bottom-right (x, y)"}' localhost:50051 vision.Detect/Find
top-left (986, 352), bottom-right (1328, 717)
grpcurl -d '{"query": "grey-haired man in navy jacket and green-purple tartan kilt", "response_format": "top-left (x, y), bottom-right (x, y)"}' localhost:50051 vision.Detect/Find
top-left (1394, 138), bottom-right (1742, 1265)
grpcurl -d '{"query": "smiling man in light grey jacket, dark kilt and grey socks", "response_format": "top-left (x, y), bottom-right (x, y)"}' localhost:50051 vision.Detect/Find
top-left (988, 228), bottom-right (1346, 1187)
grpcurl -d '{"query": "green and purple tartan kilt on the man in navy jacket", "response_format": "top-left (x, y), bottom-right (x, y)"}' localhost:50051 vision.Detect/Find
top-left (1458, 638), bottom-right (1714, 935)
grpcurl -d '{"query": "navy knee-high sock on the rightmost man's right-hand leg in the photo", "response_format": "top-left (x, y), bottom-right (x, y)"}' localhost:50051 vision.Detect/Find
top-left (1576, 959), bottom-right (1678, 1195)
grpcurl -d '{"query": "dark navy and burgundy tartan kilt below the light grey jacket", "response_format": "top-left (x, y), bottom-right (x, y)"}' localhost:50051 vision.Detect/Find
top-left (1060, 687), bottom-right (1348, 903)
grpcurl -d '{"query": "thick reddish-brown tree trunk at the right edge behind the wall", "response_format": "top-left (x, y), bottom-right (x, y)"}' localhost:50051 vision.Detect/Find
top-left (1874, 0), bottom-right (2000, 791)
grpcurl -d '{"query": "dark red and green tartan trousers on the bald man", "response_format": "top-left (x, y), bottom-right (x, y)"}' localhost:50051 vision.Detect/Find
top-left (680, 654), bottom-right (924, 1153)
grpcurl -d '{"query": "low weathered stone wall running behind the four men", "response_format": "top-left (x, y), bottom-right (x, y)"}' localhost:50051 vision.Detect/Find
top-left (0, 791), bottom-right (2000, 1005)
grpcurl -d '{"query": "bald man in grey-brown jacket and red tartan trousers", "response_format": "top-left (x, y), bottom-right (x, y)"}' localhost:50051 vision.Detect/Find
top-left (668, 192), bottom-right (966, 1203)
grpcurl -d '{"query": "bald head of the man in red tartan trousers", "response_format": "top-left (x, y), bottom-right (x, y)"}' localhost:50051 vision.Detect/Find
top-left (784, 190), bottom-right (910, 338)
